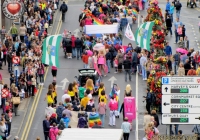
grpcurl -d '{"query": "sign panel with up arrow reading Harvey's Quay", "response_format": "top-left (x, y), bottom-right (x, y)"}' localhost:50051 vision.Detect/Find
top-left (162, 85), bottom-right (200, 94)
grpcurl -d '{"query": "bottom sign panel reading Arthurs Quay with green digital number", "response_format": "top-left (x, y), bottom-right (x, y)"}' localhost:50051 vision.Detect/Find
top-left (162, 114), bottom-right (200, 124)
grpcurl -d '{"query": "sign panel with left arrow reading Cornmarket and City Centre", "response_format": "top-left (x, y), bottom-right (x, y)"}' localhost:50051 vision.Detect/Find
top-left (162, 95), bottom-right (200, 114)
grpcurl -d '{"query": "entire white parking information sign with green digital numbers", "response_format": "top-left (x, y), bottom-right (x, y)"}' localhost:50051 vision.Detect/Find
top-left (162, 76), bottom-right (200, 124)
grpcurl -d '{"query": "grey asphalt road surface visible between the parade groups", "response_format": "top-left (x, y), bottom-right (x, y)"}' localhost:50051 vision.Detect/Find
top-left (19, 0), bottom-right (199, 140)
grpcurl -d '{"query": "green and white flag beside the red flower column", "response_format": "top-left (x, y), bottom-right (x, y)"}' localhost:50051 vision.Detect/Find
top-left (135, 22), bottom-right (154, 50)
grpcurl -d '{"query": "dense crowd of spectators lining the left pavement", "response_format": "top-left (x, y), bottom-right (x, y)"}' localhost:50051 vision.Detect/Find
top-left (0, 1), bottom-right (57, 140)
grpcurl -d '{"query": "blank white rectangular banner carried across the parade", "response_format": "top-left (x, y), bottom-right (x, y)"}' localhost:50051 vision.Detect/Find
top-left (85, 24), bottom-right (118, 34)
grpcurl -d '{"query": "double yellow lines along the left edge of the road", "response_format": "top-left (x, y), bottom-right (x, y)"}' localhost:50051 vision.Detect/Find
top-left (21, 8), bottom-right (62, 140)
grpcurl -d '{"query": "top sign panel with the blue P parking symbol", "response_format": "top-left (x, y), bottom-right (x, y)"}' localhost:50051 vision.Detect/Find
top-left (162, 76), bottom-right (200, 85)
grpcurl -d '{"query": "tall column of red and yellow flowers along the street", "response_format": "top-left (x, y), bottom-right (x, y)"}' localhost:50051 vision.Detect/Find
top-left (144, 0), bottom-right (168, 112)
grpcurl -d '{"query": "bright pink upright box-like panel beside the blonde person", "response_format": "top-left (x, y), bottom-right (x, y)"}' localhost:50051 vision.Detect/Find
top-left (124, 97), bottom-right (136, 122)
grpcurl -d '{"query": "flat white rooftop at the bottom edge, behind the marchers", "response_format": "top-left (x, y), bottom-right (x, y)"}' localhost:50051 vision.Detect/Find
top-left (58, 128), bottom-right (123, 140)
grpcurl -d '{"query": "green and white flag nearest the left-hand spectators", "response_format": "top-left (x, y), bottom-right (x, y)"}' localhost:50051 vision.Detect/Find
top-left (42, 35), bottom-right (62, 67)
